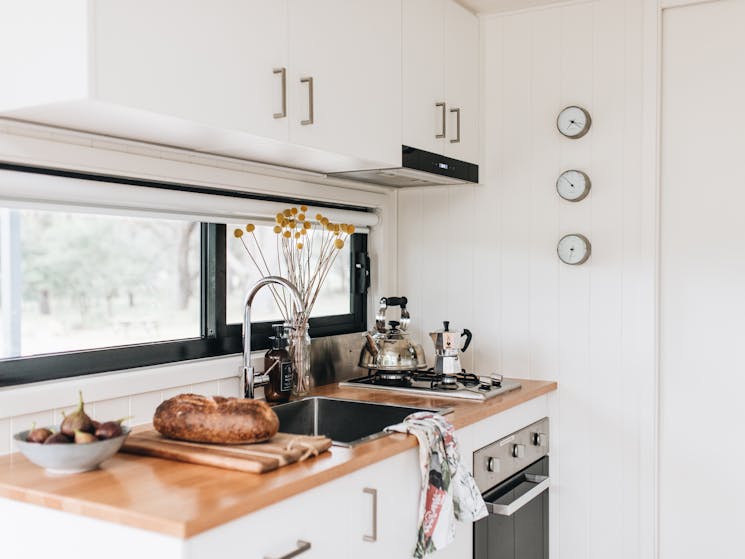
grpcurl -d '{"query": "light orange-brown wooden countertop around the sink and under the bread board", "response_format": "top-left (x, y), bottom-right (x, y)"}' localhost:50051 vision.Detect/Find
top-left (0, 380), bottom-right (557, 538)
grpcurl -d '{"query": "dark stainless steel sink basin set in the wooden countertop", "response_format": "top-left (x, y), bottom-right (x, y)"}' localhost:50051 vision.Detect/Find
top-left (272, 396), bottom-right (453, 447)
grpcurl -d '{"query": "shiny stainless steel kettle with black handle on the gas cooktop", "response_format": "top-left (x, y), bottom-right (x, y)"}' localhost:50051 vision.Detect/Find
top-left (359, 297), bottom-right (427, 371)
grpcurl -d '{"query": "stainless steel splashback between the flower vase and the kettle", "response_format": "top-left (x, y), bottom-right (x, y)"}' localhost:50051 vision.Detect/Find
top-left (310, 332), bottom-right (368, 386)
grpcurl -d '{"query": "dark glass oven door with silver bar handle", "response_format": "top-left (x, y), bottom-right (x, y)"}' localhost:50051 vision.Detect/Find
top-left (473, 456), bottom-right (548, 559)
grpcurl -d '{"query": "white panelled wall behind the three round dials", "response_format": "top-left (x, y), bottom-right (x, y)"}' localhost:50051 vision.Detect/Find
top-left (397, 0), bottom-right (654, 559)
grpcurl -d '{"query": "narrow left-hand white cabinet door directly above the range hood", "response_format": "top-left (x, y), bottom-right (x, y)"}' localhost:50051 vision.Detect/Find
top-left (402, 0), bottom-right (448, 153)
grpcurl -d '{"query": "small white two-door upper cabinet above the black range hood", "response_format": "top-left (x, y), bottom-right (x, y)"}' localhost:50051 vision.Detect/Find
top-left (402, 0), bottom-right (479, 163)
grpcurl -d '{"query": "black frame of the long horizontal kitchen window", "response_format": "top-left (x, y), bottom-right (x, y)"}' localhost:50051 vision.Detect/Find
top-left (0, 163), bottom-right (370, 388)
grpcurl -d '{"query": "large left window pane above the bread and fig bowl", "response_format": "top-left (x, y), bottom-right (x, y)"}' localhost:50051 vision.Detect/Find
top-left (0, 208), bottom-right (201, 358)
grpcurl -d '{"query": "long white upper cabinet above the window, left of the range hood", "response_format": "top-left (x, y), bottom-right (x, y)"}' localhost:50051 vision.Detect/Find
top-left (0, 0), bottom-right (401, 172)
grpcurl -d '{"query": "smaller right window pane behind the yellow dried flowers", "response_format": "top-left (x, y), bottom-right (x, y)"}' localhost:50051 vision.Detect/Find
top-left (226, 224), bottom-right (351, 324)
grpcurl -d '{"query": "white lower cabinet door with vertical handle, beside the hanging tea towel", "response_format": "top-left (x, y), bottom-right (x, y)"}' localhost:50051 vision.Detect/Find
top-left (347, 450), bottom-right (421, 559)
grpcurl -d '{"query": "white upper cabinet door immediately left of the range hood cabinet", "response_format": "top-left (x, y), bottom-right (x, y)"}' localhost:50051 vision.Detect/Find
top-left (288, 0), bottom-right (401, 168)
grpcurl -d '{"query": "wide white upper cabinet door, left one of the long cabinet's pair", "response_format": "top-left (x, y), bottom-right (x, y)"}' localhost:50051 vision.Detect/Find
top-left (92, 0), bottom-right (288, 140)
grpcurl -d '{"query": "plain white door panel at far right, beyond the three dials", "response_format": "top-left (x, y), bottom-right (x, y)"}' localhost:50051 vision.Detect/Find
top-left (659, 0), bottom-right (745, 559)
